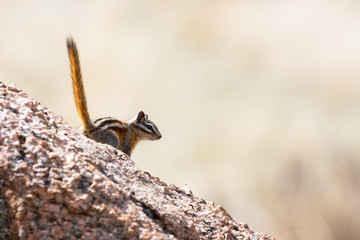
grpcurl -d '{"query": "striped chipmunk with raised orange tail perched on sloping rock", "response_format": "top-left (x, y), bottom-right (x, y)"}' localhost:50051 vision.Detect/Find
top-left (66, 36), bottom-right (161, 156)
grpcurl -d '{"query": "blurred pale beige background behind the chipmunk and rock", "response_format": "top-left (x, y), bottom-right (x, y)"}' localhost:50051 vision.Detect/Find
top-left (0, 0), bottom-right (360, 240)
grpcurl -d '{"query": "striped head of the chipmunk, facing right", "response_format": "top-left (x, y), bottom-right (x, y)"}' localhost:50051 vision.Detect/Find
top-left (131, 111), bottom-right (161, 140)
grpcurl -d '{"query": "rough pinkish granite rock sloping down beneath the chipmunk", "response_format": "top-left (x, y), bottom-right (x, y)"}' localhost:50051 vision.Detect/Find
top-left (0, 82), bottom-right (273, 240)
